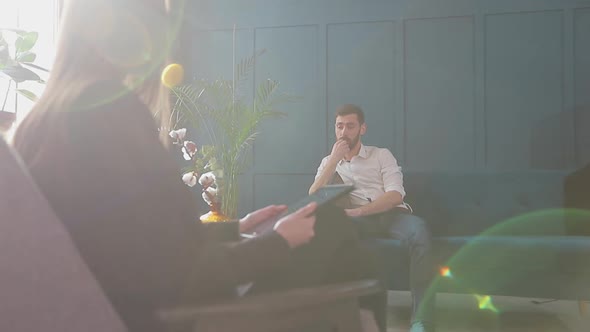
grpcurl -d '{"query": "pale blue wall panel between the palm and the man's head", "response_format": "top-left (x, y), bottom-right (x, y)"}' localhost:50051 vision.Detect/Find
top-left (254, 26), bottom-right (326, 173)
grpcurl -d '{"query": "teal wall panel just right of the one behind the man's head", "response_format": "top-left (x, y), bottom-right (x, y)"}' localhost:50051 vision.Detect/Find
top-left (404, 17), bottom-right (476, 170)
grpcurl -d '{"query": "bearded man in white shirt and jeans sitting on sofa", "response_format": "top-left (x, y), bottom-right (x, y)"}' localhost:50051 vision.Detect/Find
top-left (309, 104), bottom-right (435, 332)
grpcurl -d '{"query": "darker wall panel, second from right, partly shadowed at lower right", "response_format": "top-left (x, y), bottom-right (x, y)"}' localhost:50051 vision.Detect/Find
top-left (485, 11), bottom-right (566, 170)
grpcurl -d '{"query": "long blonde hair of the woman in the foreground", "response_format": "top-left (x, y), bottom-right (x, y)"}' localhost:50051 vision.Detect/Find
top-left (14, 0), bottom-right (180, 152)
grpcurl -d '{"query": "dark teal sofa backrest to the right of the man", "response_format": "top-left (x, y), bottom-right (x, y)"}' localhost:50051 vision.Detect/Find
top-left (404, 170), bottom-right (566, 236)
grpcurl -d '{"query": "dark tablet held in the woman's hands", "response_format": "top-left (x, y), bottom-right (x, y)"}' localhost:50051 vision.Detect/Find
top-left (242, 184), bottom-right (354, 238)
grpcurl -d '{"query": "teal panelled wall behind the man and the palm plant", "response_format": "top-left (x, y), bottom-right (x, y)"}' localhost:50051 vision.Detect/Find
top-left (184, 0), bottom-right (590, 217)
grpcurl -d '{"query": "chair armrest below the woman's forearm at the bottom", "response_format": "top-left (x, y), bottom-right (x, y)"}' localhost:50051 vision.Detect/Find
top-left (157, 280), bottom-right (382, 322)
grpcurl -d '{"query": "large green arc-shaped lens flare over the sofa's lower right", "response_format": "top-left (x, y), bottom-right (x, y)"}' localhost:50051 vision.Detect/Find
top-left (416, 208), bottom-right (590, 326)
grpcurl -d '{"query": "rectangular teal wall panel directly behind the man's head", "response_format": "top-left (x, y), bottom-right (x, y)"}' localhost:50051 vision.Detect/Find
top-left (327, 22), bottom-right (402, 152)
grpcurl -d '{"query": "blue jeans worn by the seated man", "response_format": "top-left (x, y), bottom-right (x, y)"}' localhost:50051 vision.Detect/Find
top-left (353, 209), bottom-right (436, 324)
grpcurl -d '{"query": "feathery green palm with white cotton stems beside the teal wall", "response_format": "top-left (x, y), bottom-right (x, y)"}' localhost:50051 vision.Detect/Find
top-left (170, 50), bottom-right (292, 221)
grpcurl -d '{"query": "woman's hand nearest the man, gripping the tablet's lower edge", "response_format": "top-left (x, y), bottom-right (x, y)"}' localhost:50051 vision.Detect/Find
top-left (274, 202), bottom-right (318, 248)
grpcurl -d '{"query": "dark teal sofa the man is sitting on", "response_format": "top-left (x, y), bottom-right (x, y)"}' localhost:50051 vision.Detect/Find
top-left (367, 171), bottom-right (590, 300)
